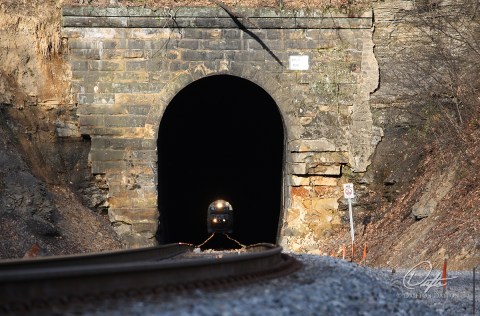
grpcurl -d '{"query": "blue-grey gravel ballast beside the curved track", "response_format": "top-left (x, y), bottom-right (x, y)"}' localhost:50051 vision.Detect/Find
top-left (53, 253), bottom-right (480, 316)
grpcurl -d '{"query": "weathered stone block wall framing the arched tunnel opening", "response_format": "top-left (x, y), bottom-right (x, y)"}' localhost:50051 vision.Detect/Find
top-left (62, 7), bottom-right (382, 252)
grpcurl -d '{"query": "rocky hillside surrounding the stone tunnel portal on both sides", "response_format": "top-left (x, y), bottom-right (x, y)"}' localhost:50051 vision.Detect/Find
top-left (0, 0), bottom-right (480, 269)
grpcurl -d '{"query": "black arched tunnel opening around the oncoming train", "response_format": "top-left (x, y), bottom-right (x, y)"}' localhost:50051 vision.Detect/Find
top-left (157, 75), bottom-right (284, 248)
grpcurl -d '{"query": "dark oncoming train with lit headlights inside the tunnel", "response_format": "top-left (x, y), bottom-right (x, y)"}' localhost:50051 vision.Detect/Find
top-left (207, 200), bottom-right (233, 234)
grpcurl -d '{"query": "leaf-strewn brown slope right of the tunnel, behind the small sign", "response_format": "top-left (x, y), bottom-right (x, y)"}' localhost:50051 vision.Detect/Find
top-left (358, 116), bottom-right (480, 269)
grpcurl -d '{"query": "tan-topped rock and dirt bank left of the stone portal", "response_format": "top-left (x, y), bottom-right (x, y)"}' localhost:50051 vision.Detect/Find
top-left (0, 0), bottom-right (122, 258)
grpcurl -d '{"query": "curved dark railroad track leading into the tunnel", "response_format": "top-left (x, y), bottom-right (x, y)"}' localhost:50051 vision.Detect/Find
top-left (0, 243), bottom-right (301, 314)
